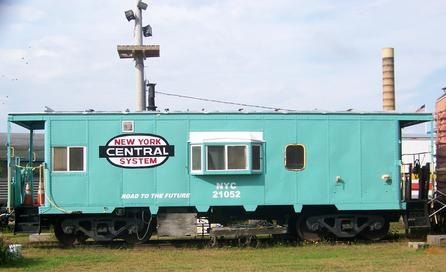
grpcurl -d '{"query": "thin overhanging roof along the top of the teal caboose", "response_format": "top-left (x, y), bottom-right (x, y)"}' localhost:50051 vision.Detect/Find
top-left (8, 111), bottom-right (433, 130)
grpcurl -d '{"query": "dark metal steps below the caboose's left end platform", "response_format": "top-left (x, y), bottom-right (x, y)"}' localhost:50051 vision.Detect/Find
top-left (14, 207), bottom-right (40, 233)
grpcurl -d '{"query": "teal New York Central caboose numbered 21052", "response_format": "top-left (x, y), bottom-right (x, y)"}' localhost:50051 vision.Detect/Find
top-left (8, 112), bottom-right (432, 243)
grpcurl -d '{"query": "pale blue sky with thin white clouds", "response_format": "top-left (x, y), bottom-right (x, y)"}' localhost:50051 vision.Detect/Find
top-left (0, 0), bottom-right (446, 132)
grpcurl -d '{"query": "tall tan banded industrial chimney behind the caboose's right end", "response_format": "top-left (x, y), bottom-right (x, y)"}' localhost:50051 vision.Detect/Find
top-left (382, 48), bottom-right (395, 111)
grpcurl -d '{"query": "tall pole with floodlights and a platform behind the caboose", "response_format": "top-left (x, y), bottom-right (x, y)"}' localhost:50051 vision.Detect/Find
top-left (118, 0), bottom-right (160, 111)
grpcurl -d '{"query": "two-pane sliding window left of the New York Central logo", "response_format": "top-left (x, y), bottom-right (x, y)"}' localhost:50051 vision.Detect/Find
top-left (53, 146), bottom-right (85, 172)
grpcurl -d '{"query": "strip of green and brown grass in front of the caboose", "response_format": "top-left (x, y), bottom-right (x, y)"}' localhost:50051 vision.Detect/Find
top-left (0, 224), bottom-right (446, 272)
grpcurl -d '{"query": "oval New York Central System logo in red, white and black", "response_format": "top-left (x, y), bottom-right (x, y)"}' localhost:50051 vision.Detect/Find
top-left (99, 134), bottom-right (175, 168)
